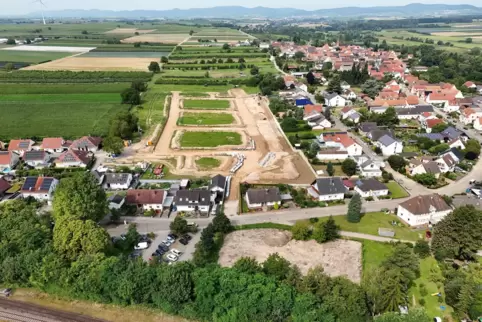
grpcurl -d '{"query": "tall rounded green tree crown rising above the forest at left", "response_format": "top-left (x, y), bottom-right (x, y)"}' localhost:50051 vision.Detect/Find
top-left (53, 172), bottom-right (107, 222)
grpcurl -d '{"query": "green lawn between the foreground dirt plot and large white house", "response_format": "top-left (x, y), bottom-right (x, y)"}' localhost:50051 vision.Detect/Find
top-left (320, 212), bottom-right (423, 241)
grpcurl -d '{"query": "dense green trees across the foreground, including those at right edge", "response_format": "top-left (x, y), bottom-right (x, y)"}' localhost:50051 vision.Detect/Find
top-left (0, 174), bottom-right (482, 322)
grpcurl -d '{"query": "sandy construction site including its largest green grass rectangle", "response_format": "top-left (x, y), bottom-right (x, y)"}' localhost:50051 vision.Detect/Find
top-left (117, 89), bottom-right (315, 200)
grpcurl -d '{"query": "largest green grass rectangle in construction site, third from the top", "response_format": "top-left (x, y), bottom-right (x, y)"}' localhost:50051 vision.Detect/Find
top-left (180, 131), bottom-right (242, 148)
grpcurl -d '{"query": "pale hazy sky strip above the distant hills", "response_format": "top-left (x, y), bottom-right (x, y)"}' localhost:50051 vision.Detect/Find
top-left (0, 0), bottom-right (480, 15)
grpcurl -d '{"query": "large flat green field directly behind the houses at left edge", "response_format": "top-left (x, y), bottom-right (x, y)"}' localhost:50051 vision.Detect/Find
top-left (0, 83), bottom-right (130, 140)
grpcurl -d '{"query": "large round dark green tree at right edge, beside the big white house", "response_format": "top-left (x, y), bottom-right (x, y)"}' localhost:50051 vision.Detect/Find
top-left (432, 206), bottom-right (482, 260)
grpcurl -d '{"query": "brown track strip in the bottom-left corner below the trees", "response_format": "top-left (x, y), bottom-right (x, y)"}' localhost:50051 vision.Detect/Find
top-left (0, 298), bottom-right (106, 322)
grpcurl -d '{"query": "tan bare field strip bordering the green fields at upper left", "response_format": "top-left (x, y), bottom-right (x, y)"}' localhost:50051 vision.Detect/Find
top-left (24, 57), bottom-right (156, 71)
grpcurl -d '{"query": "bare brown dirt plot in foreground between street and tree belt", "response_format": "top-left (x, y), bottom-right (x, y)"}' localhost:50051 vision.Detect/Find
top-left (219, 229), bottom-right (362, 283)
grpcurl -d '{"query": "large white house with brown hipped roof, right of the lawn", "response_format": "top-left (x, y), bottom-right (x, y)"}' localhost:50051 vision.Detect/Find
top-left (397, 193), bottom-right (452, 227)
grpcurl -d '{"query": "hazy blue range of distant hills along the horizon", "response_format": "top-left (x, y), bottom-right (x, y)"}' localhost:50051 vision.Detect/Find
top-left (29, 3), bottom-right (482, 19)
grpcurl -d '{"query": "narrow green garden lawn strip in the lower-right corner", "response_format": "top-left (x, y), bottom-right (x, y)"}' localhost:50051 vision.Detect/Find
top-left (409, 257), bottom-right (453, 317)
